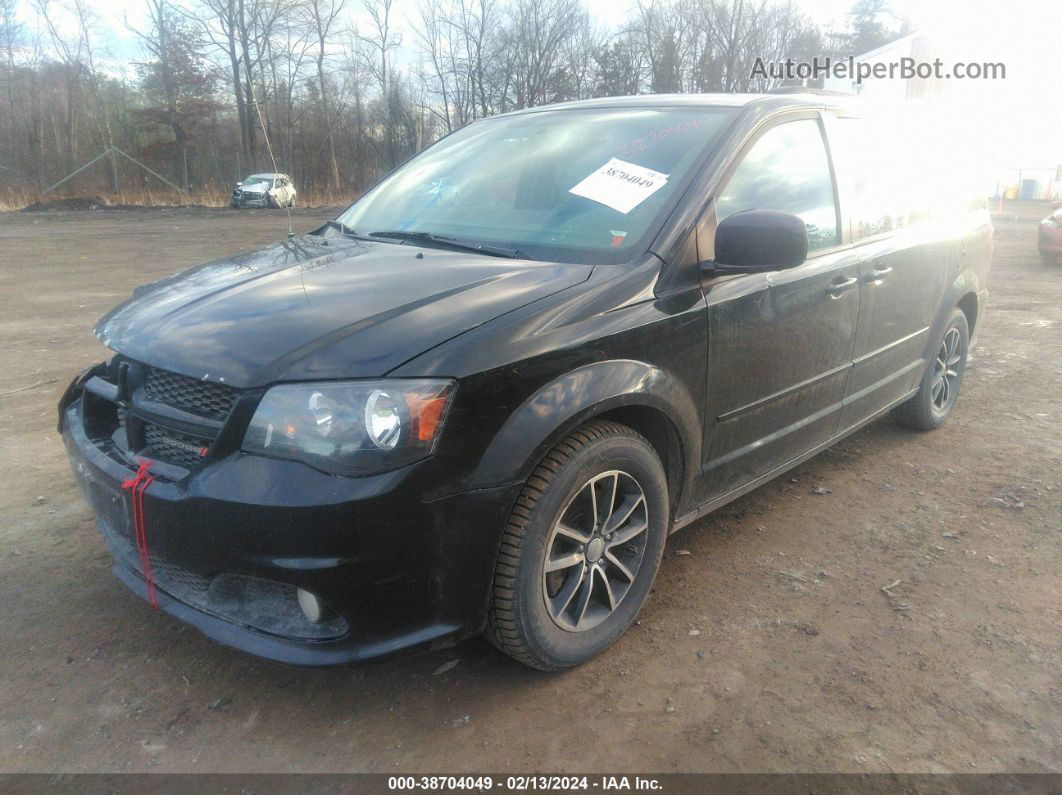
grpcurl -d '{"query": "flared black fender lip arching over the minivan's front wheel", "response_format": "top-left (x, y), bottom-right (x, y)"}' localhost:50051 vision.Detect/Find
top-left (472, 360), bottom-right (701, 517)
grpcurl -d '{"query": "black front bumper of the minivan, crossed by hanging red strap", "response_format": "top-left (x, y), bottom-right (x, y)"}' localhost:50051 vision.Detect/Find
top-left (62, 398), bottom-right (517, 666)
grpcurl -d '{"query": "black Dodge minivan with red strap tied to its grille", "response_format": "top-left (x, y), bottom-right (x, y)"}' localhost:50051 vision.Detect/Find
top-left (59, 94), bottom-right (992, 669)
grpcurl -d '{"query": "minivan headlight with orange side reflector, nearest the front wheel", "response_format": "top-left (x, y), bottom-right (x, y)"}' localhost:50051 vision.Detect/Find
top-left (243, 379), bottom-right (453, 476)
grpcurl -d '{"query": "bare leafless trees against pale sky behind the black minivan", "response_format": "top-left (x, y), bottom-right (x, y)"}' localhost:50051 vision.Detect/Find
top-left (0, 0), bottom-right (905, 195)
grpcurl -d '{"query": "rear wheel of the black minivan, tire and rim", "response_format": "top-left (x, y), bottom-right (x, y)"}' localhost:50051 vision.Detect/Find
top-left (892, 308), bottom-right (970, 431)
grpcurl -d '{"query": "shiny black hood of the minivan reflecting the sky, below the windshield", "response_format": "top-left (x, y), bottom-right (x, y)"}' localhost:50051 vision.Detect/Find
top-left (96, 235), bottom-right (593, 387)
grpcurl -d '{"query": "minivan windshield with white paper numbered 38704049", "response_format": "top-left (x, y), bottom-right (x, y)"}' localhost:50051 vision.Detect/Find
top-left (339, 107), bottom-right (734, 264)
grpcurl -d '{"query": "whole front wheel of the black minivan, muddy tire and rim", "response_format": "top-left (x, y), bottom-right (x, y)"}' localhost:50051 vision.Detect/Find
top-left (486, 420), bottom-right (669, 671)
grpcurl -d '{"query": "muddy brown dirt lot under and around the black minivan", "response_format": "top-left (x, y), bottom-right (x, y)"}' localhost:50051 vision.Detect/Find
top-left (0, 202), bottom-right (1062, 773)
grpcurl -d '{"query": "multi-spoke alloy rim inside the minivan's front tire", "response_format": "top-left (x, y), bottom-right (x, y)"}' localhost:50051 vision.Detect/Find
top-left (543, 470), bottom-right (649, 633)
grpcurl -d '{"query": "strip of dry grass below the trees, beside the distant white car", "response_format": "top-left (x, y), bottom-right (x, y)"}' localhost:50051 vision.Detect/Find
top-left (0, 187), bottom-right (357, 212)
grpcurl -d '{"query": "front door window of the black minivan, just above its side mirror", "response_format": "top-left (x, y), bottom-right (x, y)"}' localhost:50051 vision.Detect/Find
top-left (716, 119), bottom-right (841, 250)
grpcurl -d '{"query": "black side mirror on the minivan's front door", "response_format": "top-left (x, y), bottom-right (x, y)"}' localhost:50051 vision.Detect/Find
top-left (702, 210), bottom-right (807, 273)
